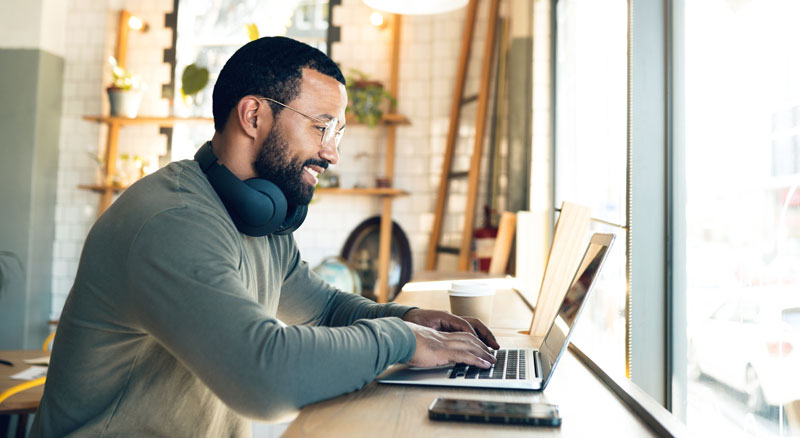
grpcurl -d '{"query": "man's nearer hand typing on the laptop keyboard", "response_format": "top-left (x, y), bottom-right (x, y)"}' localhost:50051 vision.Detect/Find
top-left (406, 321), bottom-right (497, 369)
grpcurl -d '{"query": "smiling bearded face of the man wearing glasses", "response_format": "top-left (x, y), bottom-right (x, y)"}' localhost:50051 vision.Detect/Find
top-left (253, 69), bottom-right (347, 205)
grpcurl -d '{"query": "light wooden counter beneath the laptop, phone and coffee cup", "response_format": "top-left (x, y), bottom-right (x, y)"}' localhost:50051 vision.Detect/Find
top-left (284, 290), bottom-right (658, 438)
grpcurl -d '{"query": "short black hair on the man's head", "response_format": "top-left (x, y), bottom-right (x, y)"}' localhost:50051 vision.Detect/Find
top-left (212, 37), bottom-right (345, 132)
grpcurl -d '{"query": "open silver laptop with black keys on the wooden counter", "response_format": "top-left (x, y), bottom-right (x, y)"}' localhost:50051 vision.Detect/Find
top-left (377, 233), bottom-right (614, 391)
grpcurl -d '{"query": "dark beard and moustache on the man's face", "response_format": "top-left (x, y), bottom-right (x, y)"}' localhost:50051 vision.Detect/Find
top-left (253, 124), bottom-right (328, 206)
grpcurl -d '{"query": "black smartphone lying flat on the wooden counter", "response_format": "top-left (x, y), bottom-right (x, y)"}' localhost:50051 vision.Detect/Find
top-left (428, 397), bottom-right (561, 427)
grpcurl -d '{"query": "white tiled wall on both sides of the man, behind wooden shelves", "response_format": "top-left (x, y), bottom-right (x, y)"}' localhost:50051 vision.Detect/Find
top-left (52, 0), bottom-right (506, 318)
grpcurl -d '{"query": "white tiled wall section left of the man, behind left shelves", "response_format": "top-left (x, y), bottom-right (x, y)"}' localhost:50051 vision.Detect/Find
top-left (51, 0), bottom-right (172, 318)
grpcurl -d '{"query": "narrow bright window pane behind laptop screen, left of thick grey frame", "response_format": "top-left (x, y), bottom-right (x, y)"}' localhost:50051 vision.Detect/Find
top-left (555, 0), bottom-right (628, 375)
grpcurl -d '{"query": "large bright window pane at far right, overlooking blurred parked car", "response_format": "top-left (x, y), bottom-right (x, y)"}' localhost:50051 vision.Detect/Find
top-left (674, 0), bottom-right (800, 436)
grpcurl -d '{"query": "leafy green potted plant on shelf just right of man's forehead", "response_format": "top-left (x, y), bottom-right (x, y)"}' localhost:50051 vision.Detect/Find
top-left (347, 69), bottom-right (397, 128)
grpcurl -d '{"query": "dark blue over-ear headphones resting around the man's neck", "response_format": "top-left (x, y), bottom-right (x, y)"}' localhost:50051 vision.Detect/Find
top-left (194, 142), bottom-right (308, 237)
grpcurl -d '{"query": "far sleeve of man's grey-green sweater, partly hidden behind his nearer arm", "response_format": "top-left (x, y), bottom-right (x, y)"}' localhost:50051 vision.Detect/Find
top-left (278, 239), bottom-right (414, 327)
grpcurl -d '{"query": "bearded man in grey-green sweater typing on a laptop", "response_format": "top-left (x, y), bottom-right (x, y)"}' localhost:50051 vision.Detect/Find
top-left (33, 37), bottom-right (498, 437)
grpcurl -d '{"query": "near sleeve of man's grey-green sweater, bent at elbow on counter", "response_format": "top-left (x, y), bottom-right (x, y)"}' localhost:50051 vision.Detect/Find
top-left (125, 209), bottom-right (416, 420)
